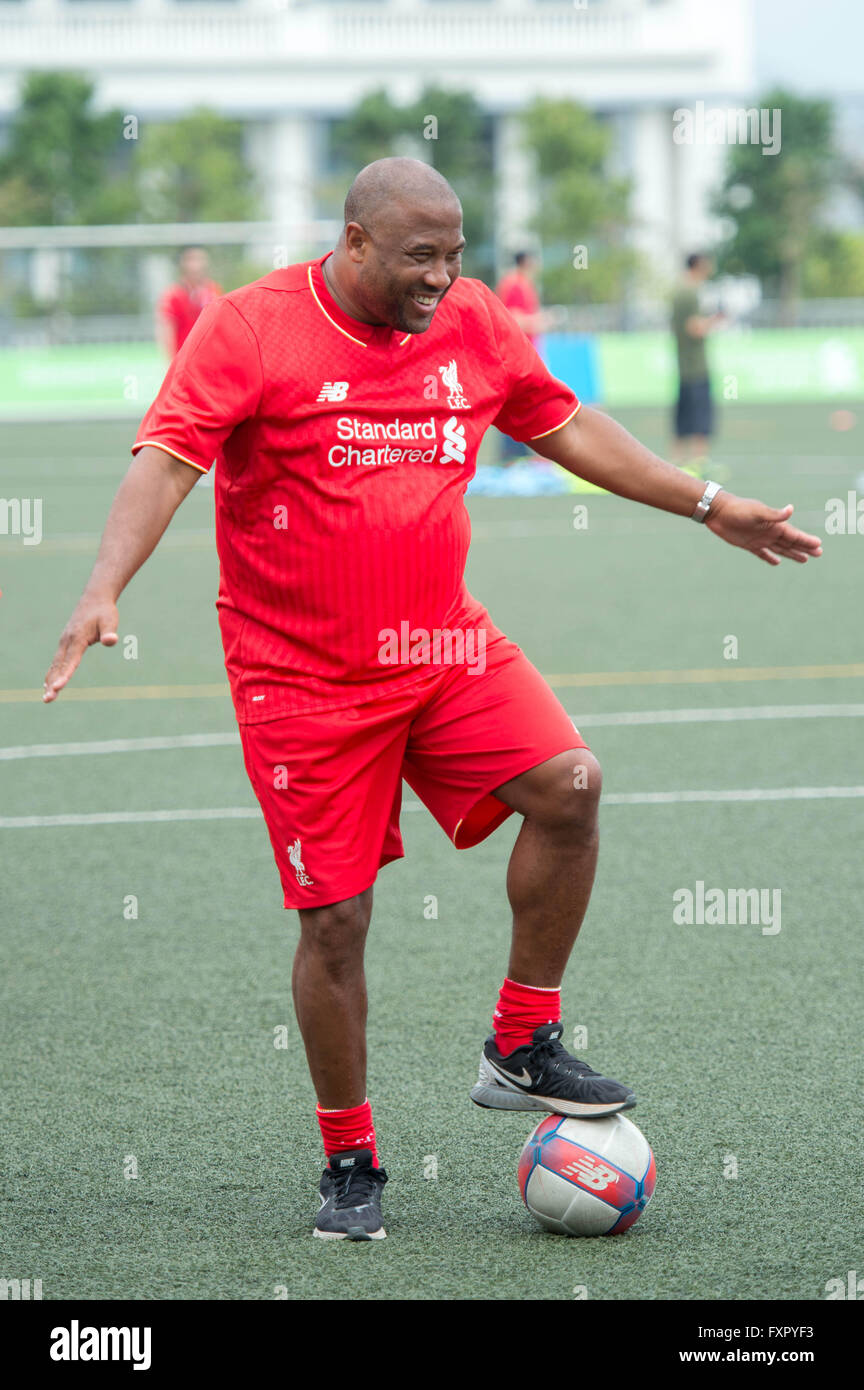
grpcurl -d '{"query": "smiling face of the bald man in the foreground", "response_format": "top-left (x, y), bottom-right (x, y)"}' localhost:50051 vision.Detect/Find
top-left (344, 199), bottom-right (465, 334)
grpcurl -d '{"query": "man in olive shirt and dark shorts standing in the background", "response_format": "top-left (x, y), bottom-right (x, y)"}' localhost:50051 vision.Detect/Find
top-left (671, 253), bottom-right (724, 477)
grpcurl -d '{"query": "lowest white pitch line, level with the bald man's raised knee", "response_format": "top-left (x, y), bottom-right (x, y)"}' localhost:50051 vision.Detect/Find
top-left (0, 787), bottom-right (864, 830)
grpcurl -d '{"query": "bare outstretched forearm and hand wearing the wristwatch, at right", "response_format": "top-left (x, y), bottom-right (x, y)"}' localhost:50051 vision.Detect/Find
top-left (531, 406), bottom-right (822, 564)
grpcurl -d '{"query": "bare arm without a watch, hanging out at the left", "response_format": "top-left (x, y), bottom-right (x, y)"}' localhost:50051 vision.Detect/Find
top-left (42, 445), bottom-right (199, 703)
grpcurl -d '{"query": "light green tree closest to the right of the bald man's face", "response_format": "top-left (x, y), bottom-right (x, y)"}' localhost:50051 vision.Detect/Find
top-left (522, 97), bottom-right (639, 304)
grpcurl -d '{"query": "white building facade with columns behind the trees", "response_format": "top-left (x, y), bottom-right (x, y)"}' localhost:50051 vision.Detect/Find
top-left (0, 0), bottom-right (753, 274)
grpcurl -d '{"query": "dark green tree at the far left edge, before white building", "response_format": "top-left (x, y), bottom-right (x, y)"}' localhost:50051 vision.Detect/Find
top-left (0, 72), bottom-right (135, 227)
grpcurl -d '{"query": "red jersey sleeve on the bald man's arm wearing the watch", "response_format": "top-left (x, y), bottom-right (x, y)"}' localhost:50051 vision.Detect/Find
top-left (486, 289), bottom-right (579, 443)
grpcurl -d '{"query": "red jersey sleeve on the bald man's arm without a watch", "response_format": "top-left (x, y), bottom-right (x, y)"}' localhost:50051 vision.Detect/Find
top-left (132, 299), bottom-right (263, 473)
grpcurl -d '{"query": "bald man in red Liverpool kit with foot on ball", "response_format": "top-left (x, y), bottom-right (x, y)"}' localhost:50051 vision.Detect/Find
top-left (44, 158), bottom-right (820, 1240)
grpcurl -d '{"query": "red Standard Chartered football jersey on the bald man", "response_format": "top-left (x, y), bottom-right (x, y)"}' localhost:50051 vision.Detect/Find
top-left (133, 256), bottom-right (579, 723)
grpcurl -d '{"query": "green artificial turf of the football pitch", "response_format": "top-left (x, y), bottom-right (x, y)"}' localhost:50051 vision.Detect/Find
top-left (0, 406), bottom-right (864, 1300)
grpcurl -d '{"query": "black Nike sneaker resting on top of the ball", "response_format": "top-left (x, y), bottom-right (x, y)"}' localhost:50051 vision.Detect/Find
top-left (471, 1023), bottom-right (636, 1119)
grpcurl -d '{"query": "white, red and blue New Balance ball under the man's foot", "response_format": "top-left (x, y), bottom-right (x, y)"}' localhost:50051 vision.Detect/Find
top-left (520, 1115), bottom-right (656, 1236)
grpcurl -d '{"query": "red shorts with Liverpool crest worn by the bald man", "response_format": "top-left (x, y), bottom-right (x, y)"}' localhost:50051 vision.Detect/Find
top-left (240, 641), bottom-right (588, 908)
